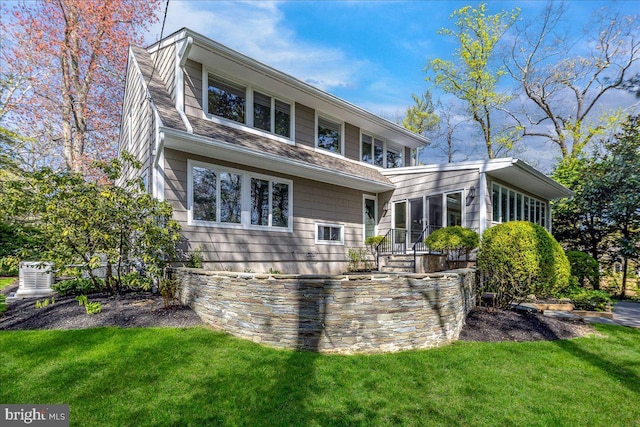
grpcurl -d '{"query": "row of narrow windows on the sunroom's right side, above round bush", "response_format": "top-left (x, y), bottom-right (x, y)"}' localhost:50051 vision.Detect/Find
top-left (491, 183), bottom-right (547, 228)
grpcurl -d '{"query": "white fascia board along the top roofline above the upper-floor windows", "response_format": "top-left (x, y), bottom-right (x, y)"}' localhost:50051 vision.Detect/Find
top-left (180, 28), bottom-right (429, 148)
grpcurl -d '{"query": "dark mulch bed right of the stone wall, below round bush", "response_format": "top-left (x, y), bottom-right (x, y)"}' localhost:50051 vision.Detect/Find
top-left (460, 308), bottom-right (595, 342)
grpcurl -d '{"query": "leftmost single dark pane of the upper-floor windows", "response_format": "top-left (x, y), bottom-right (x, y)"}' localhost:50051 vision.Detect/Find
top-left (207, 75), bottom-right (247, 123)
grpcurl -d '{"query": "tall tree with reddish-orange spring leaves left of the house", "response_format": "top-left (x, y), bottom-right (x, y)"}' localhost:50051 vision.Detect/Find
top-left (0, 0), bottom-right (161, 171)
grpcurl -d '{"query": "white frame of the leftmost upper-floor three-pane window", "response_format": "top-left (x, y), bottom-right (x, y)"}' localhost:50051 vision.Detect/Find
top-left (202, 67), bottom-right (296, 145)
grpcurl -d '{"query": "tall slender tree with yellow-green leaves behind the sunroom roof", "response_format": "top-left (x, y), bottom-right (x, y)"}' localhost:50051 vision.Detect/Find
top-left (426, 3), bottom-right (520, 159)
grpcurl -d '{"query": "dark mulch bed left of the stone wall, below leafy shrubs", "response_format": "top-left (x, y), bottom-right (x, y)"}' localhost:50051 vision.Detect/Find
top-left (0, 286), bottom-right (203, 330)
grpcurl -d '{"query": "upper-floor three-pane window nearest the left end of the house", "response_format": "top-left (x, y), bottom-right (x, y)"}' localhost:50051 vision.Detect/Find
top-left (206, 74), bottom-right (292, 139)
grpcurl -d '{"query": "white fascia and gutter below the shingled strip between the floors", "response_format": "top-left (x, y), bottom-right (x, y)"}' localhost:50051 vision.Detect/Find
top-left (161, 127), bottom-right (396, 193)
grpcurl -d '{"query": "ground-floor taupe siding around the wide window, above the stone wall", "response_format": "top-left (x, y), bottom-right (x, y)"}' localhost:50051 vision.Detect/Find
top-left (165, 149), bottom-right (363, 273)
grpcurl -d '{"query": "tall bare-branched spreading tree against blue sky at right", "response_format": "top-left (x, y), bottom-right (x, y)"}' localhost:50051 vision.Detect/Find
top-left (508, 3), bottom-right (640, 161)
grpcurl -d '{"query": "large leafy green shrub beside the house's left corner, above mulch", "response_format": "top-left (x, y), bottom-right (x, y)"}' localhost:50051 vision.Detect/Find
top-left (0, 154), bottom-right (180, 291)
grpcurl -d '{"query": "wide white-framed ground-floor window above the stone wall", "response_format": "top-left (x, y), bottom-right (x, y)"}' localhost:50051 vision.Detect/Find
top-left (189, 162), bottom-right (292, 231)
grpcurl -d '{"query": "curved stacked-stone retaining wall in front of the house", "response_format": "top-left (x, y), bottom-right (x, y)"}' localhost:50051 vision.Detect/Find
top-left (173, 268), bottom-right (475, 354)
